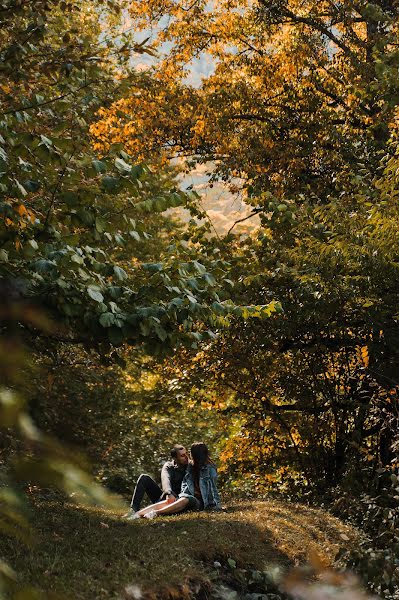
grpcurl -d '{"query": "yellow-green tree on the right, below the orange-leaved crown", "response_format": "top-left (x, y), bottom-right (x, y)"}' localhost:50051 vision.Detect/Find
top-left (162, 139), bottom-right (399, 491)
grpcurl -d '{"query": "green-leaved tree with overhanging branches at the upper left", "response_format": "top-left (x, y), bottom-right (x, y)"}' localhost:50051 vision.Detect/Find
top-left (0, 0), bottom-right (278, 349)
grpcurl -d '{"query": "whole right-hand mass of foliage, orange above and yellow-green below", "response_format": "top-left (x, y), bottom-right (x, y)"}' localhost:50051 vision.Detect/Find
top-left (92, 0), bottom-right (399, 589)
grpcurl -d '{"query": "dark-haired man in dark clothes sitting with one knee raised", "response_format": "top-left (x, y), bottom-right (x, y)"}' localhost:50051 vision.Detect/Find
top-left (124, 445), bottom-right (188, 519)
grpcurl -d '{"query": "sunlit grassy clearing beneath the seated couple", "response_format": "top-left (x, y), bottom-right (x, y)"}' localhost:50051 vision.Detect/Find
top-left (2, 500), bottom-right (358, 600)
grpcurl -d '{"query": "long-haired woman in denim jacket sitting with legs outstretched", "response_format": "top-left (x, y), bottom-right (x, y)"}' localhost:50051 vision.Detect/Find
top-left (136, 442), bottom-right (221, 519)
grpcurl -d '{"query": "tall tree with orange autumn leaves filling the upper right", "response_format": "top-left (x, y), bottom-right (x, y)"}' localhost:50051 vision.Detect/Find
top-left (93, 0), bottom-right (398, 202)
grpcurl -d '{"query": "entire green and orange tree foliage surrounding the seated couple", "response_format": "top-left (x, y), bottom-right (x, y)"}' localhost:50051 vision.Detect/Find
top-left (0, 0), bottom-right (399, 594)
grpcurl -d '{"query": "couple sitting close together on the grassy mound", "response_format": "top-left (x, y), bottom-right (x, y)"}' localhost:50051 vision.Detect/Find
top-left (125, 442), bottom-right (221, 520)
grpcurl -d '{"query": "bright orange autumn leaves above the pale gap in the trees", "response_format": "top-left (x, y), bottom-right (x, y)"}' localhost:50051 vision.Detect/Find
top-left (91, 0), bottom-right (369, 197)
